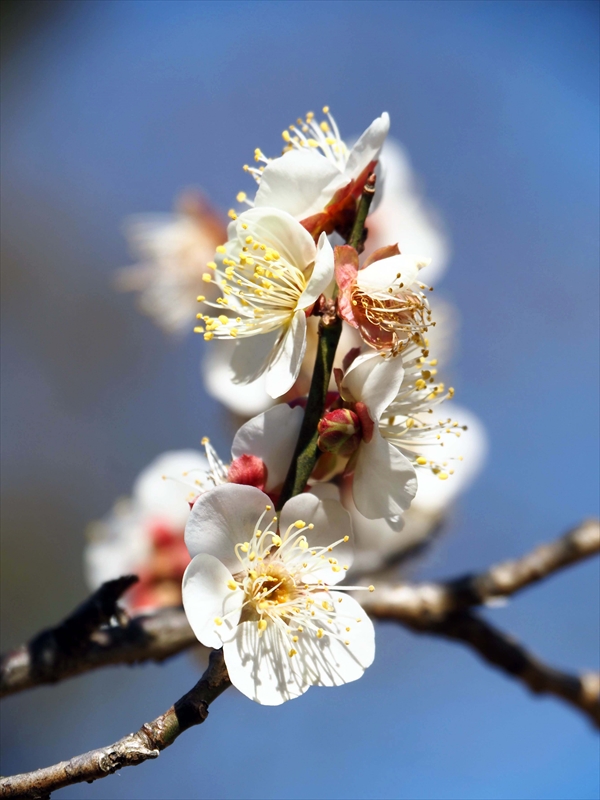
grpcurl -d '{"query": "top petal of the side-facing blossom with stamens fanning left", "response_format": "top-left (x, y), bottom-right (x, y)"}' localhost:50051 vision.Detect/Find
top-left (236, 206), bottom-right (316, 270)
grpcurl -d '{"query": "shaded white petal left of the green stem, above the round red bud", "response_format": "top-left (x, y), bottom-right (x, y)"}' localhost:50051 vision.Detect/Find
top-left (231, 403), bottom-right (304, 491)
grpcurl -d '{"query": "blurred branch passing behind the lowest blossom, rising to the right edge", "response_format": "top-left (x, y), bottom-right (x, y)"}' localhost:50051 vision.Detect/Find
top-left (0, 520), bottom-right (600, 697)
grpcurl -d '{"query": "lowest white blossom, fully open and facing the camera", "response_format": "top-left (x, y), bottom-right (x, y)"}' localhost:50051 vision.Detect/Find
top-left (182, 485), bottom-right (375, 705)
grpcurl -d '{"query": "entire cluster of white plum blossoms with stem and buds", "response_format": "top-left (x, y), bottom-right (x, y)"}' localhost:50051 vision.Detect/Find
top-left (86, 107), bottom-right (484, 704)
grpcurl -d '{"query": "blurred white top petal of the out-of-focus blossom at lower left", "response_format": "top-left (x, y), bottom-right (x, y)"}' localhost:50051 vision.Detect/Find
top-left (132, 450), bottom-right (212, 528)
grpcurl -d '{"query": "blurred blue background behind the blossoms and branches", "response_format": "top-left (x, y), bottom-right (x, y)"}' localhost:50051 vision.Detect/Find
top-left (2, 0), bottom-right (599, 800)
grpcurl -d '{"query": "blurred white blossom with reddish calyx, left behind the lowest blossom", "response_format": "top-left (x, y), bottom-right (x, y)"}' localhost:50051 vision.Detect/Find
top-left (84, 450), bottom-right (213, 610)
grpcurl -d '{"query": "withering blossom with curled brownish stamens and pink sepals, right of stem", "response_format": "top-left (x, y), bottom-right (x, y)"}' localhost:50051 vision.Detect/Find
top-left (335, 245), bottom-right (434, 354)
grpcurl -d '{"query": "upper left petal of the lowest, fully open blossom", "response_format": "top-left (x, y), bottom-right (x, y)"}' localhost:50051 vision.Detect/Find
top-left (185, 483), bottom-right (271, 572)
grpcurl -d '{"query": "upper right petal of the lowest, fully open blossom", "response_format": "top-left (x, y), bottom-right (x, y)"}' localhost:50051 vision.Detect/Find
top-left (279, 492), bottom-right (354, 586)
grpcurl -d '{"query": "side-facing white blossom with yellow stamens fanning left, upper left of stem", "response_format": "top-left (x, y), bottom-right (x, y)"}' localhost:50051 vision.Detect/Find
top-left (195, 208), bottom-right (333, 397)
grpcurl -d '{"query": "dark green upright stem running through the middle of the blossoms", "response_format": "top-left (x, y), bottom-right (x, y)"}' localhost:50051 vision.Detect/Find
top-left (277, 175), bottom-right (375, 510)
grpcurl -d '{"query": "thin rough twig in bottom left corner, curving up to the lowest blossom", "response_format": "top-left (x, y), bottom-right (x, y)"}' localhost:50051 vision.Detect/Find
top-left (0, 650), bottom-right (231, 800)
